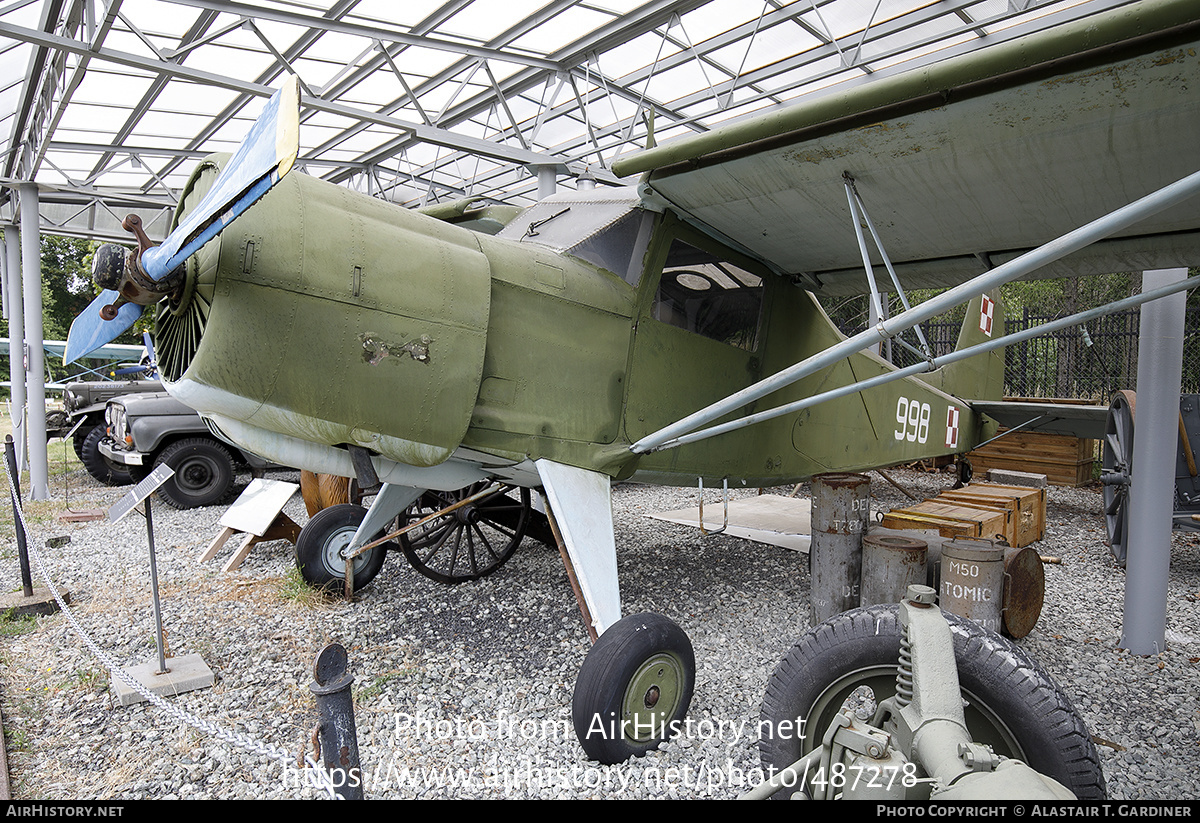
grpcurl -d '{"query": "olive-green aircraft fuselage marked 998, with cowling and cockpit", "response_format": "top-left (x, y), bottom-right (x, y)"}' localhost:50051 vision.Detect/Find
top-left (156, 153), bottom-right (993, 488)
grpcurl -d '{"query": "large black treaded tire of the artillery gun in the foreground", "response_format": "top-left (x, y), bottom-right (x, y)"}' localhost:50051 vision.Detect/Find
top-left (758, 606), bottom-right (1105, 800)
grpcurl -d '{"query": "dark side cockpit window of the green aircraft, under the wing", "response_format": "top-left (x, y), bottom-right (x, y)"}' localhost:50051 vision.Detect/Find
top-left (650, 239), bottom-right (763, 352)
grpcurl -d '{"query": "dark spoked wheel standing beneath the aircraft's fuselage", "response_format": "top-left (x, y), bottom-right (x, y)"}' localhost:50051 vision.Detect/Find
top-left (400, 482), bottom-right (530, 583)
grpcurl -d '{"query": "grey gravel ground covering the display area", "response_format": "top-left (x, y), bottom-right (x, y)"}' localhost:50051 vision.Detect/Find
top-left (0, 460), bottom-right (1200, 800)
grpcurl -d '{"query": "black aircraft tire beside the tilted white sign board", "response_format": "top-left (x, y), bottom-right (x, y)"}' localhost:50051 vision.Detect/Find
top-left (296, 503), bottom-right (396, 591)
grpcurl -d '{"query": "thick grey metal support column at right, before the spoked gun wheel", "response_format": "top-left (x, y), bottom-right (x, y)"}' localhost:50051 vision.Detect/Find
top-left (1121, 269), bottom-right (1188, 654)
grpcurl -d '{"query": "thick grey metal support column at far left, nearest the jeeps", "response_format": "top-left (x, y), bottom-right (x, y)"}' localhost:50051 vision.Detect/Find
top-left (19, 182), bottom-right (50, 500)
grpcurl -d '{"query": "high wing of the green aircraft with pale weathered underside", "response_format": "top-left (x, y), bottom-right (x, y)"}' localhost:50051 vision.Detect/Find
top-left (613, 0), bottom-right (1200, 295)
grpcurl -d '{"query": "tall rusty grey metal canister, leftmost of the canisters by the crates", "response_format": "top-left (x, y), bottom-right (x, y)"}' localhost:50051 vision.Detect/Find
top-left (809, 473), bottom-right (871, 625)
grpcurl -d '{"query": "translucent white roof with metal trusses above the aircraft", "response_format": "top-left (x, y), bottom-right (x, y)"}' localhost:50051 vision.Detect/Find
top-left (0, 0), bottom-right (1134, 226)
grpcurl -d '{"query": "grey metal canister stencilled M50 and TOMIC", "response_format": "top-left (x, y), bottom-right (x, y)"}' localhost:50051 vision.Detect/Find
top-left (937, 540), bottom-right (1004, 633)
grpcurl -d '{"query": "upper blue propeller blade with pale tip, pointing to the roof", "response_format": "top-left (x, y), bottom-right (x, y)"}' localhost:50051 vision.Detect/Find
top-left (142, 76), bottom-right (300, 280)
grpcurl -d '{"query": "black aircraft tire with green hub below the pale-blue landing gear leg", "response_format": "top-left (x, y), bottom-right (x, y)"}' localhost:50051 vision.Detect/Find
top-left (571, 612), bottom-right (696, 765)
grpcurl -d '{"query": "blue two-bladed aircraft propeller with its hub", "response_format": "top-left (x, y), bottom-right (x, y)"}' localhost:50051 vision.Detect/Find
top-left (62, 77), bottom-right (300, 365)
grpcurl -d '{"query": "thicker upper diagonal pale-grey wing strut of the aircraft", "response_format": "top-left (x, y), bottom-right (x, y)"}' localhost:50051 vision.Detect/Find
top-left (630, 164), bottom-right (1200, 455)
